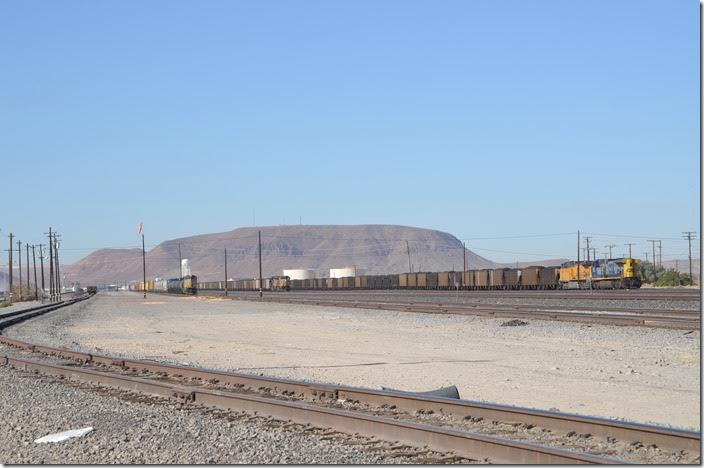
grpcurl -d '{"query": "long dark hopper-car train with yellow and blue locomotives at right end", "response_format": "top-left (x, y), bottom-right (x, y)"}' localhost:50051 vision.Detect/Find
top-left (198, 258), bottom-right (641, 291)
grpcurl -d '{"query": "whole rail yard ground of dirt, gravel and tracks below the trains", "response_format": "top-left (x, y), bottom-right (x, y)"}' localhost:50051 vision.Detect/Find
top-left (0, 290), bottom-right (700, 463)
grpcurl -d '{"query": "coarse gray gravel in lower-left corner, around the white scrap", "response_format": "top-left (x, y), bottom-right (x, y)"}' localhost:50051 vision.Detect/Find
top-left (0, 367), bottom-right (398, 464)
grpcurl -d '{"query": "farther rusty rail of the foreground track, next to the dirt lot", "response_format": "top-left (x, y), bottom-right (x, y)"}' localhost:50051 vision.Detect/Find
top-left (0, 335), bottom-right (701, 453)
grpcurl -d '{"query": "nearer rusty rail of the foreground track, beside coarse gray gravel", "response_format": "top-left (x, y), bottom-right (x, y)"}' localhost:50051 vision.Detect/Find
top-left (3, 356), bottom-right (622, 464)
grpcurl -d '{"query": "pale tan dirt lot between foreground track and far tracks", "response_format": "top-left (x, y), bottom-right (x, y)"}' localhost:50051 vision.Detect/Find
top-left (7, 293), bottom-right (700, 430)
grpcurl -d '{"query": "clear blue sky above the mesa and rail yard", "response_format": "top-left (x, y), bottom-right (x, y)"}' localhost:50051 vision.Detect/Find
top-left (0, 0), bottom-right (700, 262)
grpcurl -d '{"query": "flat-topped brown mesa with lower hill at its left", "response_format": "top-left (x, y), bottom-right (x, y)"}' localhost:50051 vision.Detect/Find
top-left (62, 225), bottom-right (501, 285)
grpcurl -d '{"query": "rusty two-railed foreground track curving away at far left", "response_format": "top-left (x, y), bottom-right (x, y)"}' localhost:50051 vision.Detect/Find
top-left (0, 298), bottom-right (701, 464)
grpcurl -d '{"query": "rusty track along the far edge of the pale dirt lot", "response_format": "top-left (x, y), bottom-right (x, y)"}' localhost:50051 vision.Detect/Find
top-left (199, 291), bottom-right (701, 330)
